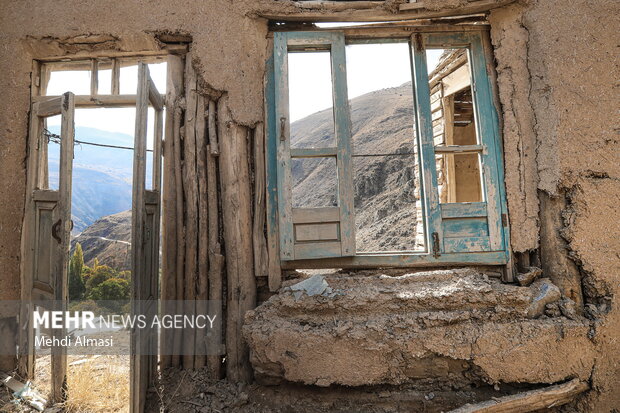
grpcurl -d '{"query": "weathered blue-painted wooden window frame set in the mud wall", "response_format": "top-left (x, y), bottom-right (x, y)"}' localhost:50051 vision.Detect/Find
top-left (265, 31), bottom-right (510, 268)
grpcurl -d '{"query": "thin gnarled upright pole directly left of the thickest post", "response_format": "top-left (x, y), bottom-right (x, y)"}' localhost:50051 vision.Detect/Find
top-left (206, 101), bottom-right (224, 380)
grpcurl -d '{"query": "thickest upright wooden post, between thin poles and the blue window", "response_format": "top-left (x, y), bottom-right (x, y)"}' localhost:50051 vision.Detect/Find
top-left (218, 96), bottom-right (256, 382)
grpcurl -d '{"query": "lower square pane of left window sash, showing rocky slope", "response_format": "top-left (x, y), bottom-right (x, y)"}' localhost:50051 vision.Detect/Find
top-left (291, 157), bottom-right (338, 208)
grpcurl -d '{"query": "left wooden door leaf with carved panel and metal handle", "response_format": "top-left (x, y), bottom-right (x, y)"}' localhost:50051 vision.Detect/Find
top-left (19, 92), bottom-right (75, 403)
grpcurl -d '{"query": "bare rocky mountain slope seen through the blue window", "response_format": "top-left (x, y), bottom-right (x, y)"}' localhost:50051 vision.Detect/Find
top-left (291, 83), bottom-right (416, 252)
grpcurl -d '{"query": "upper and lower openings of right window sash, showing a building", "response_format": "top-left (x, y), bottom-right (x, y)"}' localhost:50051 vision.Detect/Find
top-left (426, 49), bottom-right (484, 203)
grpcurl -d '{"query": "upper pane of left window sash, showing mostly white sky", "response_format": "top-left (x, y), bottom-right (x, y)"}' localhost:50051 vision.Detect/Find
top-left (288, 51), bottom-right (336, 148)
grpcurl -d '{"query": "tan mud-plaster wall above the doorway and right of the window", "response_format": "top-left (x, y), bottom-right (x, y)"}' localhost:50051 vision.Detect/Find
top-left (0, 0), bottom-right (620, 411)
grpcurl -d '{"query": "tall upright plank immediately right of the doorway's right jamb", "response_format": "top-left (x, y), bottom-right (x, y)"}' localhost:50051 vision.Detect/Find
top-left (182, 56), bottom-right (198, 369)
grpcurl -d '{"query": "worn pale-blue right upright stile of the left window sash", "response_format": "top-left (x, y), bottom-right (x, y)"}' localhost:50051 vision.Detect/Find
top-left (332, 33), bottom-right (355, 258)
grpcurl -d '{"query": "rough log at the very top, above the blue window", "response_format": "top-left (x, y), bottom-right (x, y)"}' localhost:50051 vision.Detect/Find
top-left (254, 0), bottom-right (515, 22)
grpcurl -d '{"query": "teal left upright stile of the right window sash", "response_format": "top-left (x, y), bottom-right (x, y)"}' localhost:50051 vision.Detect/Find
top-left (411, 34), bottom-right (443, 253)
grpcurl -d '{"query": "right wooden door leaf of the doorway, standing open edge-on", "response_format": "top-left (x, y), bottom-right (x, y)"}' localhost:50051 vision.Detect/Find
top-left (130, 63), bottom-right (164, 413)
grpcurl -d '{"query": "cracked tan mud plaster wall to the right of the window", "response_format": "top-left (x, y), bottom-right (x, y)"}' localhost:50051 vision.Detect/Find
top-left (489, 0), bottom-right (620, 412)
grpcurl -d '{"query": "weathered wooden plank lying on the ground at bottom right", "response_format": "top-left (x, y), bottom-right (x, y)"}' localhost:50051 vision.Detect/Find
top-left (450, 379), bottom-right (590, 413)
